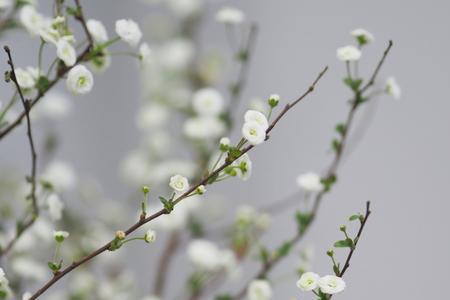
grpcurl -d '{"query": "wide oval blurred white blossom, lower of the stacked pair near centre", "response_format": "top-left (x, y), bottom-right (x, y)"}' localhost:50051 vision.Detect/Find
top-left (183, 117), bottom-right (226, 139)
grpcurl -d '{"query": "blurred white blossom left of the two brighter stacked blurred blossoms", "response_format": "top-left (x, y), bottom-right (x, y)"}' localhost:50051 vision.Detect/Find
top-left (136, 103), bottom-right (170, 130)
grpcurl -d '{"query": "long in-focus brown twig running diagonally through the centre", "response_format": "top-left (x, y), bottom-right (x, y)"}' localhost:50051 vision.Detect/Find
top-left (29, 67), bottom-right (328, 300)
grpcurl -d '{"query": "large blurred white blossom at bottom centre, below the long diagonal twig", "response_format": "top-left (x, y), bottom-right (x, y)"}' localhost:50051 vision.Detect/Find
top-left (187, 239), bottom-right (223, 272)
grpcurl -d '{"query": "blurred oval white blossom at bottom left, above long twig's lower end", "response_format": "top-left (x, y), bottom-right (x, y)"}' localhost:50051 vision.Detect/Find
top-left (11, 256), bottom-right (49, 281)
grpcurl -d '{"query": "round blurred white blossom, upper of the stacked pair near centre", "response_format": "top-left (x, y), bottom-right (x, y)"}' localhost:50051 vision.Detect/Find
top-left (192, 88), bottom-right (224, 116)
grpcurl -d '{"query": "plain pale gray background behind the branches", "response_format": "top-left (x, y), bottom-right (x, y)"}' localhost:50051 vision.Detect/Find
top-left (0, 0), bottom-right (450, 300)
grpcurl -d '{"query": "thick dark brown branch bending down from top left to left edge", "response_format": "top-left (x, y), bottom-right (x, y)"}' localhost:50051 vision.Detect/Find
top-left (0, 0), bottom-right (94, 140)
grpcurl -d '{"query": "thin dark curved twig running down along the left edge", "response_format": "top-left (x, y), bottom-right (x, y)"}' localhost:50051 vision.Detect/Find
top-left (0, 46), bottom-right (39, 256)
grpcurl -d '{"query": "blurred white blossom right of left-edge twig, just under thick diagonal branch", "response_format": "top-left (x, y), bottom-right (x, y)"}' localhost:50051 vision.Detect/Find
top-left (35, 91), bottom-right (72, 120)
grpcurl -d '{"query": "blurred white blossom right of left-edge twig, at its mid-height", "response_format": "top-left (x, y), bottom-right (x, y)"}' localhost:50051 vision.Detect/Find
top-left (41, 161), bottom-right (77, 191)
